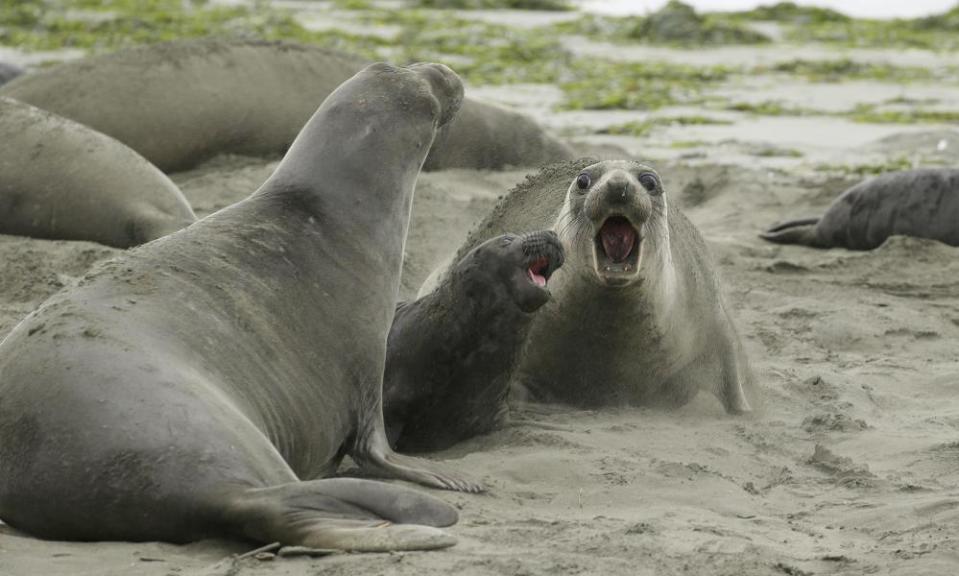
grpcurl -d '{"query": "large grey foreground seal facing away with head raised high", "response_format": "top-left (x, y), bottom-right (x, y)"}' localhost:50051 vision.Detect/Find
top-left (0, 64), bottom-right (478, 551)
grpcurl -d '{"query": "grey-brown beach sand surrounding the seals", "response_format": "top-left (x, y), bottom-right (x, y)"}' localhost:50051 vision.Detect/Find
top-left (0, 19), bottom-right (959, 576)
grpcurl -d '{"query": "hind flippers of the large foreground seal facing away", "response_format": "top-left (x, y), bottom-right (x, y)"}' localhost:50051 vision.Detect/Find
top-left (224, 478), bottom-right (457, 552)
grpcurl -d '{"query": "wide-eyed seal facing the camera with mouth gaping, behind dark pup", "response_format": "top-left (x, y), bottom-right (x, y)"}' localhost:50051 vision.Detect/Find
top-left (424, 159), bottom-right (752, 413)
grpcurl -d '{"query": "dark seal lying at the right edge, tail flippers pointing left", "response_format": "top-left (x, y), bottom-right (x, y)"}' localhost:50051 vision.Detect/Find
top-left (759, 168), bottom-right (959, 250)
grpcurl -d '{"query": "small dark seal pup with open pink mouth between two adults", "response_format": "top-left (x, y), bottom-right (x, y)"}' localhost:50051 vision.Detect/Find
top-left (383, 231), bottom-right (564, 452)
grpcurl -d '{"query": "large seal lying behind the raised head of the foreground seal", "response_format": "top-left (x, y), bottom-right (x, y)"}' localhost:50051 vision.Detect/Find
top-left (0, 40), bottom-right (572, 172)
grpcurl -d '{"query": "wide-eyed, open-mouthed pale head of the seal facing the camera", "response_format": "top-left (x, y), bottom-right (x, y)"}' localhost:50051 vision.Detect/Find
top-left (555, 160), bottom-right (675, 300)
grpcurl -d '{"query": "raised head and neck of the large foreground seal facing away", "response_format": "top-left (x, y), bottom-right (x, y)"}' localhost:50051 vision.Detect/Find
top-left (253, 64), bottom-right (463, 325)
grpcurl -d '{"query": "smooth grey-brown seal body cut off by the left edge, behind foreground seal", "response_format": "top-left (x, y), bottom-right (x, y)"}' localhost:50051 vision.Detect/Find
top-left (0, 98), bottom-right (196, 248)
